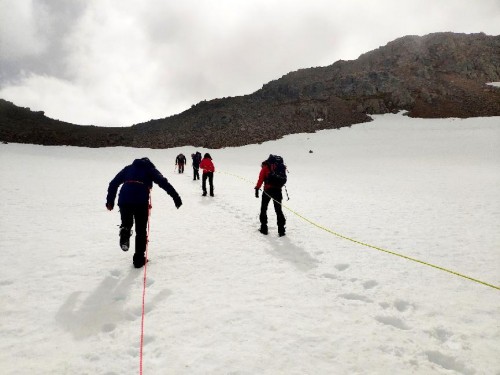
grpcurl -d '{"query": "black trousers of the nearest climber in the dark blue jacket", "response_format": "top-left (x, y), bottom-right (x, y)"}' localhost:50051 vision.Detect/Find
top-left (120, 203), bottom-right (149, 255)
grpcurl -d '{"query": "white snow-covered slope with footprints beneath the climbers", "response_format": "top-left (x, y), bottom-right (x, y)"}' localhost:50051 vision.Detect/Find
top-left (0, 114), bottom-right (500, 375)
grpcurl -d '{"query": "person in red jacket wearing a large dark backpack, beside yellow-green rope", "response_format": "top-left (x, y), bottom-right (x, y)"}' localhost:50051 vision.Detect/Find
top-left (255, 155), bottom-right (287, 237)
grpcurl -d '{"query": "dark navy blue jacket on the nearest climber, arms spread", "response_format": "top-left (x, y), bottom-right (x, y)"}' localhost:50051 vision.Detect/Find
top-left (106, 158), bottom-right (180, 206)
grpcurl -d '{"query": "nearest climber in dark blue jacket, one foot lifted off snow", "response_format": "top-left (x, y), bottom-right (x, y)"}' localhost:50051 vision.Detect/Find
top-left (106, 158), bottom-right (182, 268)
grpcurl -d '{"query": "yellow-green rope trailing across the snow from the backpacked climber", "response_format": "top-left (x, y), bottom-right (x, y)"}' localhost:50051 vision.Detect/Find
top-left (219, 172), bottom-right (500, 290)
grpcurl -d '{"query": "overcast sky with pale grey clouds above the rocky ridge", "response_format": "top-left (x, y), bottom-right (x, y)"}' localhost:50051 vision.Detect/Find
top-left (0, 0), bottom-right (500, 126)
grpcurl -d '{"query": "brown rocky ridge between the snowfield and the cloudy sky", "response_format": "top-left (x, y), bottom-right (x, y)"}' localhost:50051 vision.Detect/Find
top-left (0, 33), bottom-right (500, 148)
